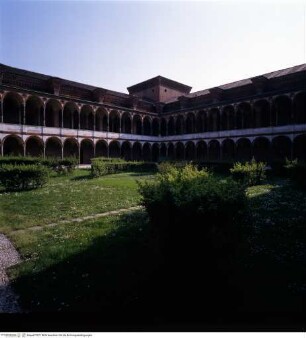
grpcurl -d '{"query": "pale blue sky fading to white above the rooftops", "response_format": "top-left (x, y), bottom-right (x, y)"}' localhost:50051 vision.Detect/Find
top-left (0, 0), bottom-right (306, 93)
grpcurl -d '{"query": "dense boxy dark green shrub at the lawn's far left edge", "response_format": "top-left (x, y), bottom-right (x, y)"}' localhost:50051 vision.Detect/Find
top-left (0, 164), bottom-right (49, 190)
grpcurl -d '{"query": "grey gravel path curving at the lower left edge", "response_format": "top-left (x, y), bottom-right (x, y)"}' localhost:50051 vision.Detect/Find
top-left (0, 234), bottom-right (22, 313)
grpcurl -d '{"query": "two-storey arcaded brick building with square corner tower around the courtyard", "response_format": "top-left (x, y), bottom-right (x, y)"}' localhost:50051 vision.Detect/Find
top-left (0, 64), bottom-right (306, 163)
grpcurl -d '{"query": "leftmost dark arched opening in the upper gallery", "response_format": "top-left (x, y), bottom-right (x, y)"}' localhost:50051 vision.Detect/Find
top-left (3, 93), bottom-right (23, 124)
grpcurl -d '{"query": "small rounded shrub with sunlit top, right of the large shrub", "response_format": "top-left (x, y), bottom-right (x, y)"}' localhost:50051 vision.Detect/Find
top-left (230, 158), bottom-right (266, 186)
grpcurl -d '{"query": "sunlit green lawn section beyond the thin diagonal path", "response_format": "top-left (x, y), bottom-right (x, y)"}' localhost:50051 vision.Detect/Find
top-left (0, 170), bottom-right (154, 234)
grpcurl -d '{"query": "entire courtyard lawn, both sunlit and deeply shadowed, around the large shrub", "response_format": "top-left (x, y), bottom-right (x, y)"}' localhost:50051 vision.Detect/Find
top-left (0, 171), bottom-right (306, 325)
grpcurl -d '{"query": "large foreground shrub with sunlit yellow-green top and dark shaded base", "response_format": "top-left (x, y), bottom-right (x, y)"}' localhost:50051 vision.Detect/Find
top-left (138, 165), bottom-right (246, 259)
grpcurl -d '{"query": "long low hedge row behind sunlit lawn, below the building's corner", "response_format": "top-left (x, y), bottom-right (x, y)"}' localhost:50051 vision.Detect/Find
top-left (91, 158), bottom-right (156, 177)
